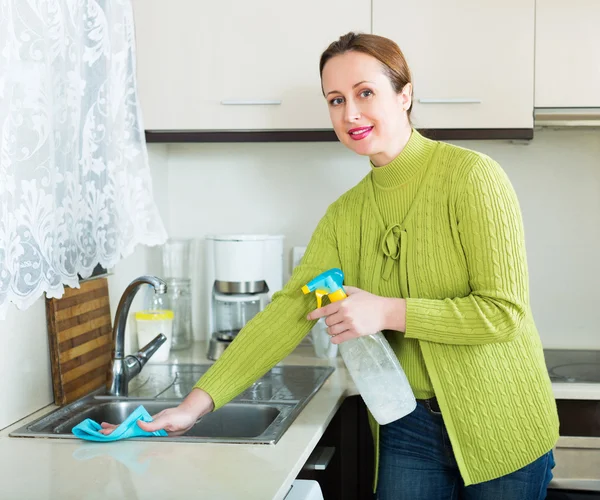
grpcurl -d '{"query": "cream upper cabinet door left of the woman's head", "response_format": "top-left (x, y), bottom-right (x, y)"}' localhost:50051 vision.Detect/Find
top-left (133, 0), bottom-right (371, 130)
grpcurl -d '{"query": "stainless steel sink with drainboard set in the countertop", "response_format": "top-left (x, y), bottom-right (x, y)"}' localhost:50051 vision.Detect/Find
top-left (10, 365), bottom-right (333, 444)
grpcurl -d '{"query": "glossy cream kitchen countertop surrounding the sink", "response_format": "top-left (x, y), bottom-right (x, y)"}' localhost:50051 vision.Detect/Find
top-left (0, 343), bottom-right (600, 500)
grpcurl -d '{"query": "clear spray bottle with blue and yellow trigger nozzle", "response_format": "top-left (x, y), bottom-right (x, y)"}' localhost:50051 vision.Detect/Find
top-left (302, 268), bottom-right (417, 425)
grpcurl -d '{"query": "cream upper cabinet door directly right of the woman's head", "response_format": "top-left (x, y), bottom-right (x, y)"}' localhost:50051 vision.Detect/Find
top-left (373, 0), bottom-right (535, 128)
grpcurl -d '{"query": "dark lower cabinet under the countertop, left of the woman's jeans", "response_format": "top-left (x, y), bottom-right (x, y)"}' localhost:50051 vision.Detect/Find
top-left (298, 396), bottom-right (375, 500)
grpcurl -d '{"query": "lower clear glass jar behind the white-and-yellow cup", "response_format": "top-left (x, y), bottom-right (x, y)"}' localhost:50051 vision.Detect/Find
top-left (166, 278), bottom-right (193, 351)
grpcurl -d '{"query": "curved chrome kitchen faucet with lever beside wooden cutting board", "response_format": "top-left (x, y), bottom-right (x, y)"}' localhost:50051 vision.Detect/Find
top-left (107, 276), bottom-right (167, 397)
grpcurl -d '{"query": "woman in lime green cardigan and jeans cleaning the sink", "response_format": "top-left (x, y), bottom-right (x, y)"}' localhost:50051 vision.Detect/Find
top-left (106, 33), bottom-right (558, 500)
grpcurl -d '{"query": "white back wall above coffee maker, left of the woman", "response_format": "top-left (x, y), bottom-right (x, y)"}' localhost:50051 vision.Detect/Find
top-left (169, 139), bottom-right (368, 339)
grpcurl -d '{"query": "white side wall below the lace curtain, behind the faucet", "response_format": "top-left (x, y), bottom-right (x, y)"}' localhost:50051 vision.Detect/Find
top-left (0, 145), bottom-right (168, 429)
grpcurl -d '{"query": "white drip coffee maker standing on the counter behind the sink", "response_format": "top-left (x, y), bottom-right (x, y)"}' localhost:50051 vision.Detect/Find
top-left (205, 234), bottom-right (283, 360)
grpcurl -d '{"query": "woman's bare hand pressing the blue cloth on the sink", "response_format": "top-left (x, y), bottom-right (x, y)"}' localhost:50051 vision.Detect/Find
top-left (100, 389), bottom-right (215, 436)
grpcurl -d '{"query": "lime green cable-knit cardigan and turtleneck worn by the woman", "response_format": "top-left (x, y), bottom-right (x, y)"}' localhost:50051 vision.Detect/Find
top-left (196, 130), bottom-right (558, 485)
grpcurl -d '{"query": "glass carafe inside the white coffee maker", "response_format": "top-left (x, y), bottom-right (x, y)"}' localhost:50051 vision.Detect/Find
top-left (213, 293), bottom-right (260, 336)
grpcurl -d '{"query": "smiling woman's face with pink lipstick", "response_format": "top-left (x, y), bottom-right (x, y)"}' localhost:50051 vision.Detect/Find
top-left (321, 51), bottom-right (411, 166)
